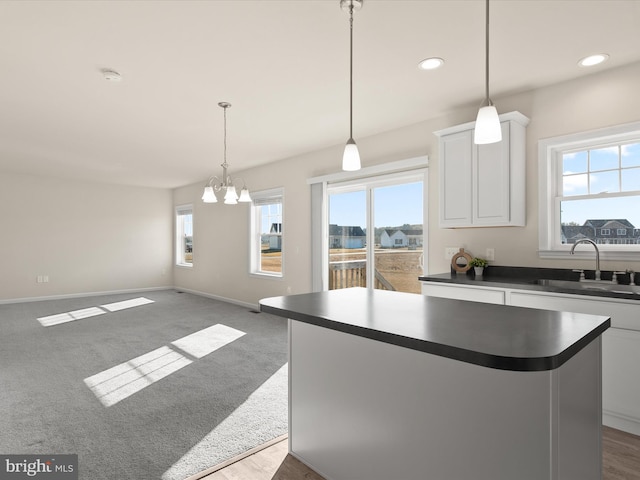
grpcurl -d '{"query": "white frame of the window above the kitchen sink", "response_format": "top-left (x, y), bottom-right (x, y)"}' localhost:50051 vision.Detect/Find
top-left (538, 122), bottom-right (640, 261)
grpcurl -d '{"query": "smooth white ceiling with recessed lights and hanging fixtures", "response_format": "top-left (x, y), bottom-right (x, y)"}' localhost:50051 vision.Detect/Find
top-left (0, 0), bottom-right (640, 188)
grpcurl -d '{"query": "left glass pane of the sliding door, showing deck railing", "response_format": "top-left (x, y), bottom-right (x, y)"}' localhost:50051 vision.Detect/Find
top-left (329, 190), bottom-right (367, 290)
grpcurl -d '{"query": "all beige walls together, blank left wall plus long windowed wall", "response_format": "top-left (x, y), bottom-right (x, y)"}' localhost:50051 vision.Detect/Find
top-left (0, 64), bottom-right (640, 304)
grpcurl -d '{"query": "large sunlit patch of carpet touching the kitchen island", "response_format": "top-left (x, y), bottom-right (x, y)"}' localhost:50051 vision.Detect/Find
top-left (162, 364), bottom-right (288, 480)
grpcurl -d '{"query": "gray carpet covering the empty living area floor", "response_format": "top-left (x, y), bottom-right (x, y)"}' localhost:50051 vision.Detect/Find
top-left (0, 291), bottom-right (287, 480)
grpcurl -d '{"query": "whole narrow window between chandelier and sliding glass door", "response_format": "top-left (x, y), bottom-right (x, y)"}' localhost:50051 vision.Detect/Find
top-left (250, 188), bottom-right (284, 277)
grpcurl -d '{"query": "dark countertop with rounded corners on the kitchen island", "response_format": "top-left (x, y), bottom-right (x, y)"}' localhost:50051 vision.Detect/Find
top-left (260, 288), bottom-right (611, 371)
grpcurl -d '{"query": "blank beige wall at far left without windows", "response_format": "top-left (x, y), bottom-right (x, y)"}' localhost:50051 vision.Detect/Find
top-left (0, 173), bottom-right (173, 301)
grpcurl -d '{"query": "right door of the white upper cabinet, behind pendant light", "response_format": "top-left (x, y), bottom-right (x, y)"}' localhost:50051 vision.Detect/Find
top-left (472, 122), bottom-right (511, 225)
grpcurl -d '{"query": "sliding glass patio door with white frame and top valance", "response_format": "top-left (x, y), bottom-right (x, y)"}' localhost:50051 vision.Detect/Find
top-left (307, 156), bottom-right (429, 292)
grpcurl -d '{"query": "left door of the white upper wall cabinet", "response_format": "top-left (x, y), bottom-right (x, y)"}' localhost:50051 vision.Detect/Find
top-left (440, 130), bottom-right (472, 227)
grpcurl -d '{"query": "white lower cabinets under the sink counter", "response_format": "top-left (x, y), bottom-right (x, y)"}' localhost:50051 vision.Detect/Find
top-left (422, 282), bottom-right (640, 435)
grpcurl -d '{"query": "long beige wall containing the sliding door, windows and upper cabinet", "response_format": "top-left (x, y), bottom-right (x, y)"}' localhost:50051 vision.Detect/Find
top-left (174, 64), bottom-right (640, 304)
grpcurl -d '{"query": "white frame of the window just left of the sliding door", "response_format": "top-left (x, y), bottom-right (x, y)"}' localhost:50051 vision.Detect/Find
top-left (249, 187), bottom-right (285, 279)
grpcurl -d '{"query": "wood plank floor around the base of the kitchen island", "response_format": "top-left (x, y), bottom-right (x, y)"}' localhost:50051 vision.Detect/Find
top-left (195, 427), bottom-right (640, 480)
